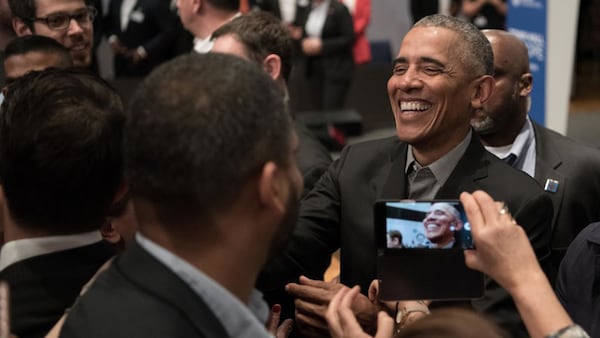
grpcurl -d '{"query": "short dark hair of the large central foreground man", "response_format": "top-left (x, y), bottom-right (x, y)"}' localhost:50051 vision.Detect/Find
top-left (125, 53), bottom-right (291, 217)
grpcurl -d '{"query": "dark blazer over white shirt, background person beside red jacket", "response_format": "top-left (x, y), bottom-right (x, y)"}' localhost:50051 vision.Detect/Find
top-left (296, 0), bottom-right (354, 80)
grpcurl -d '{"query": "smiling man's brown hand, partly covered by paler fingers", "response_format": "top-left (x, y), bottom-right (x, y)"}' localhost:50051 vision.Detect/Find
top-left (286, 276), bottom-right (377, 337)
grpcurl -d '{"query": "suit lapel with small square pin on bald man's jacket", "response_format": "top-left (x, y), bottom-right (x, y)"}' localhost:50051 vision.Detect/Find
top-left (531, 121), bottom-right (567, 228)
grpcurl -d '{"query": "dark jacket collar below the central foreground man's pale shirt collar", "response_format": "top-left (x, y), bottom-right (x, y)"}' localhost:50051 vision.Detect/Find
top-left (116, 243), bottom-right (227, 337)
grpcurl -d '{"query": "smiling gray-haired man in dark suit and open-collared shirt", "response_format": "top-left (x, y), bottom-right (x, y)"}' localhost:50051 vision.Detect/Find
top-left (261, 15), bottom-right (552, 336)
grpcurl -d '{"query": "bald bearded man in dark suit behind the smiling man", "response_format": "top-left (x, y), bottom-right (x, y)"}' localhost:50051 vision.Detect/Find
top-left (471, 30), bottom-right (600, 267)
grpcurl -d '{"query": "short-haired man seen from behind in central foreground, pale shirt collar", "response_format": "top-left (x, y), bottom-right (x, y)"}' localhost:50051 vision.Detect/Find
top-left (61, 53), bottom-right (302, 338)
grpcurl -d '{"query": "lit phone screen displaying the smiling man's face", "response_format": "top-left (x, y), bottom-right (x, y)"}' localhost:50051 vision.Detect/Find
top-left (380, 201), bottom-right (473, 249)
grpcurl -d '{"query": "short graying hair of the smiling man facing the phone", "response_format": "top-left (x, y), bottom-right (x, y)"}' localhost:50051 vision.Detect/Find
top-left (413, 14), bottom-right (494, 77)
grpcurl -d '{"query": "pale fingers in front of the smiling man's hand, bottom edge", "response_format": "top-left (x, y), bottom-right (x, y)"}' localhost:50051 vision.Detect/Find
top-left (325, 286), bottom-right (394, 338)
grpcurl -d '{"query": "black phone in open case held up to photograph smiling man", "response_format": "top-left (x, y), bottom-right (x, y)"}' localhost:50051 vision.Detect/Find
top-left (373, 200), bottom-right (484, 300)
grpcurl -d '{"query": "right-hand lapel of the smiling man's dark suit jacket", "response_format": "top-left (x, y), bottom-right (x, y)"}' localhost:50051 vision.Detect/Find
top-left (435, 133), bottom-right (489, 199)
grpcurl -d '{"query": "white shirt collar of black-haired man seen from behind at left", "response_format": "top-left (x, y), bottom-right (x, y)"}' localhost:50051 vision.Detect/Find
top-left (0, 230), bottom-right (102, 271)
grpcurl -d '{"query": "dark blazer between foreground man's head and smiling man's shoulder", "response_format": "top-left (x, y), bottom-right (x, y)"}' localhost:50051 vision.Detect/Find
top-left (294, 120), bottom-right (331, 196)
